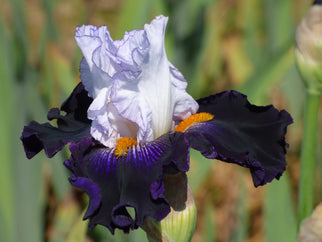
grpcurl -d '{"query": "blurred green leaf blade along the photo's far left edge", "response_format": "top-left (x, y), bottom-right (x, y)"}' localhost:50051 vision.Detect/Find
top-left (0, 15), bottom-right (18, 241)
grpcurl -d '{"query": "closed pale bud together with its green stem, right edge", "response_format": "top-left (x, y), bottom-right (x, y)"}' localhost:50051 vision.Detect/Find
top-left (295, 0), bottom-right (322, 224)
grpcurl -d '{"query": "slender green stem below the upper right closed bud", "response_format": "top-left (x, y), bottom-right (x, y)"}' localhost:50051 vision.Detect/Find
top-left (299, 91), bottom-right (320, 224)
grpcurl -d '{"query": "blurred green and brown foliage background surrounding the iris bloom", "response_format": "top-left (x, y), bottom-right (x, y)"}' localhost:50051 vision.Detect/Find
top-left (0, 0), bottom-right (322, 242)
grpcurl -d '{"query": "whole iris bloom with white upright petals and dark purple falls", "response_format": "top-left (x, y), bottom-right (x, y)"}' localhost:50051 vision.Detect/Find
top-left (21, 16), bottom-right (292, 233)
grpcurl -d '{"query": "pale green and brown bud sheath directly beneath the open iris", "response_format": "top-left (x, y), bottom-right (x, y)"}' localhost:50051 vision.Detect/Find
top-left (142, 173), bottom-right (197, 242)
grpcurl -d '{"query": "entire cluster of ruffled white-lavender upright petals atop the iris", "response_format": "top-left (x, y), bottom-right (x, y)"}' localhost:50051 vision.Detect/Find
top-left (75, 16), bottom-right (198, 146)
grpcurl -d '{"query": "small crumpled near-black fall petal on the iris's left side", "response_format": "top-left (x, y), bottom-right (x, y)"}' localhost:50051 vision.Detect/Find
top-left (20, 83), bottom-right (92, 159)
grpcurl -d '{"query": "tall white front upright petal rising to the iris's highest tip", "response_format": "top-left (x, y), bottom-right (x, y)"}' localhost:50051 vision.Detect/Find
top-left (111, 17), bottom-right (173, 142)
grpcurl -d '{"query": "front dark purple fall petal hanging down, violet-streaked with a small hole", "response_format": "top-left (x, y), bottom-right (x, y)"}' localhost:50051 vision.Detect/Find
top-left (65, 133), bottom-right (189, 233)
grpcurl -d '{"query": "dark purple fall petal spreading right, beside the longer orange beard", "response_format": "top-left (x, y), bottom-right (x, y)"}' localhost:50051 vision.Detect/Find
top-left (184, 91), bottom-right (293, 187)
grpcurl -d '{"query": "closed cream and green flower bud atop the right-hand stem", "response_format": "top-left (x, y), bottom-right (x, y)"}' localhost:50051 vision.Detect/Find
top-left (295, 0), bottom-right (322, 93)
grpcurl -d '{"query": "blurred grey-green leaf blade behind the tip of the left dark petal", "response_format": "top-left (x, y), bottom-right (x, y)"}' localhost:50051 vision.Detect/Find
top-left (11, 80), bottom-right (44, 242)
